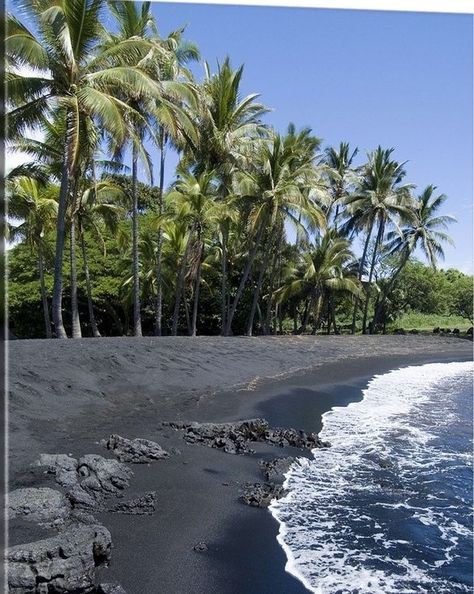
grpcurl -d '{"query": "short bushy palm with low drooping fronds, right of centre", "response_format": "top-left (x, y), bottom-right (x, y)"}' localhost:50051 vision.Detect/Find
top-left (276, 229), bottom-right (360, 333)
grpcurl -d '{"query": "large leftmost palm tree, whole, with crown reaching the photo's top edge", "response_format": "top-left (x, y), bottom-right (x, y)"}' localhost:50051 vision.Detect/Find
top-left (5, 0), bottom-right (168, 338)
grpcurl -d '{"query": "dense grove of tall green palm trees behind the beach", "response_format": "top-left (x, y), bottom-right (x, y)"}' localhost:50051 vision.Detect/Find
top-left (6, 0), bottom-right (452, 338)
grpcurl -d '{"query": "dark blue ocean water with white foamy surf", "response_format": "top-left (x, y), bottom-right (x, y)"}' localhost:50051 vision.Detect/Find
top-left (270, 362), bottom-right (473, 594)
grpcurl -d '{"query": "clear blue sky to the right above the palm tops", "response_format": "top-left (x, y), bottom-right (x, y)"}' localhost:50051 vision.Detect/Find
top-left (147, 2), bottom-right (473, 273)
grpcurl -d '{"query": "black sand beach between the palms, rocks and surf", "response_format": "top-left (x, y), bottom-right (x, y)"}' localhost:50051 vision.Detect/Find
top-left (9, 336), bottom-right (472, 594)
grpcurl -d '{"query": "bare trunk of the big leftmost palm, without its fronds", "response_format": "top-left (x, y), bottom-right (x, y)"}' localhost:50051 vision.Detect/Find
top-left (51, 112), bottom-right (74, 338)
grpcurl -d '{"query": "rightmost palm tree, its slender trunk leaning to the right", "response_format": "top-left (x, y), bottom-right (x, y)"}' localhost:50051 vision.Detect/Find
top-left (373, 185), bottom-right (456, 327)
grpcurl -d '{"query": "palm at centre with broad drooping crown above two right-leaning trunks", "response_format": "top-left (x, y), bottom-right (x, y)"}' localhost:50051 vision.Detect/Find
top-left (225, 127), bottom-right (326, 335)
